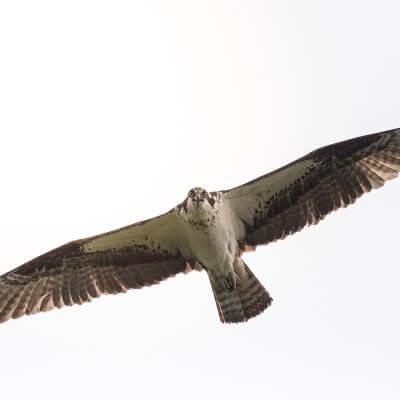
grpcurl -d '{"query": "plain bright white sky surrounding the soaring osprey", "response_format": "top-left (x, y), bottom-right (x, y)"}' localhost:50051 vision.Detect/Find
top-left (0, 0), bottom-right (400, 400)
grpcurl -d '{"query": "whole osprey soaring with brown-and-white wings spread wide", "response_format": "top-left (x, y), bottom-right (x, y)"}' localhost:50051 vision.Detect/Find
top-left (0, 129), bottom-right (400, 322)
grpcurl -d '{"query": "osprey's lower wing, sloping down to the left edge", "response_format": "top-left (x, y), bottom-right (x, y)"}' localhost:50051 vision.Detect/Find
top-left (0, 211), bottom-right (191, 322)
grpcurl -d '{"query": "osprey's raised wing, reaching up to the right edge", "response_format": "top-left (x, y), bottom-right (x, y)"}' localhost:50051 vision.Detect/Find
top-left (223, 129), bottom-right (400, 248)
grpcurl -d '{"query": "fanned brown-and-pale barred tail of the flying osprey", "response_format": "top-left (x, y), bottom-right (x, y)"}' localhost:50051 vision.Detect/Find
top-left (209, 262), bottom-right (272, 323)
